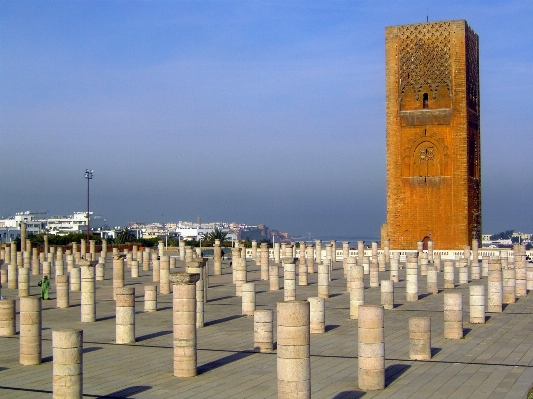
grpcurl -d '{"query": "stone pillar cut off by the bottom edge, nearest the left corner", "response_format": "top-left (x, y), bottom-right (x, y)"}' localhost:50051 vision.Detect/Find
top-left (52, 329), bottom-right (83, 399)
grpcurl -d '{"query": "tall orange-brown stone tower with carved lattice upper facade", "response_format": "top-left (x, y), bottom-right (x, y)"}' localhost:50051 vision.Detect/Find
top-left (381, 20), bottom-right (481, 249)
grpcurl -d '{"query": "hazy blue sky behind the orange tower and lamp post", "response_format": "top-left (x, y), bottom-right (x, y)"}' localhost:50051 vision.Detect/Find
top-left (0, 0), bottom-right (533, 237)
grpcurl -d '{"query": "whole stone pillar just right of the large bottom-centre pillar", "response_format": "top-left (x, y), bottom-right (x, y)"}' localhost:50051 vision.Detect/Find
top-left (357, 305), bottom-right (385, 391)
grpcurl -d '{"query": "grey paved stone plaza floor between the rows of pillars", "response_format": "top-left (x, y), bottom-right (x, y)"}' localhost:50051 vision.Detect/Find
top-left (0, 254), bottom-right (533, 399)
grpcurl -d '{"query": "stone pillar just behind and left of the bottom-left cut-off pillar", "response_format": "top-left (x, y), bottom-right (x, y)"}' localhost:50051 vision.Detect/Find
top-left (20, 296), bottom-right (42, 366)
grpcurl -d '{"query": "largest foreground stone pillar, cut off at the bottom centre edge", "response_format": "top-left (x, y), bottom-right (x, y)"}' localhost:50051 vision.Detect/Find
top-left (277, 301), bottom-right (311, 399)
